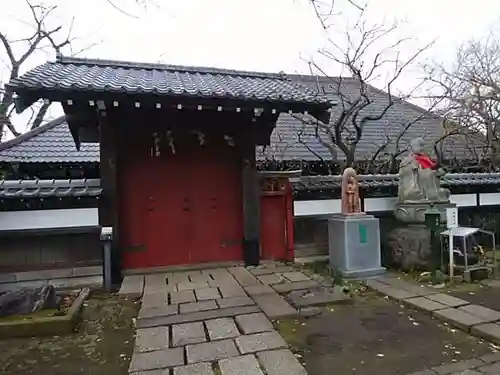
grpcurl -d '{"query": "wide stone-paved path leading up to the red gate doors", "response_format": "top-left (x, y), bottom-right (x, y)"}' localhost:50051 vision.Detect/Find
top-left (119, 264), bottom-right (347, 375)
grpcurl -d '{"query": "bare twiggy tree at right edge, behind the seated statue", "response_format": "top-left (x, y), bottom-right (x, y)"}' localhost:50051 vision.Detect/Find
top-left (425, 30), bottom-right (500, 161)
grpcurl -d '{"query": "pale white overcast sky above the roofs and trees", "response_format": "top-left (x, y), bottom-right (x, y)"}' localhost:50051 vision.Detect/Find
top-left (0, 0), bottom-right (500, 135)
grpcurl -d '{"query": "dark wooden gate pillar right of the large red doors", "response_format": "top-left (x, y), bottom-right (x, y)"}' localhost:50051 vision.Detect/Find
top-left (242, 129), bottom-right (260, 266)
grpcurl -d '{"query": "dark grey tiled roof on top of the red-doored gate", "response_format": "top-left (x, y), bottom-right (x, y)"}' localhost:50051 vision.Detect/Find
top-left (9, 57), bottom-right (330, 107)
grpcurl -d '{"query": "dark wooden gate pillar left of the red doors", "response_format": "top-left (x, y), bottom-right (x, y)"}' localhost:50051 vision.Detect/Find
top-left (97, 101), bottom-right (121, 283)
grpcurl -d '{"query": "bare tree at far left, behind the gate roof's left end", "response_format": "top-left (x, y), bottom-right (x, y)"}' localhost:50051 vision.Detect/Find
top-left (0, 0), bottom-right (90, 137)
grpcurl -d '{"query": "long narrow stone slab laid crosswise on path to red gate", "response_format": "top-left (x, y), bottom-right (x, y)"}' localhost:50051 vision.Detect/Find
top-left (137, 305), bottom-right (260, 328)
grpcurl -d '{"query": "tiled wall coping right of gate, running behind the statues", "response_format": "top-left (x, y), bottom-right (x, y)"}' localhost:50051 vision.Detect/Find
top-left (290, 173), bottom-right (500, 190)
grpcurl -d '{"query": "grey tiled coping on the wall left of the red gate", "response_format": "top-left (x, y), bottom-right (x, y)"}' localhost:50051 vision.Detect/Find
top-left (0, 179), bottom-right (102, 199)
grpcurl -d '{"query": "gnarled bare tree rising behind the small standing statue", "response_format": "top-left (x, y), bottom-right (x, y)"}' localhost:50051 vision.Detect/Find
top-left (298, 0), bottom-right (432, 166)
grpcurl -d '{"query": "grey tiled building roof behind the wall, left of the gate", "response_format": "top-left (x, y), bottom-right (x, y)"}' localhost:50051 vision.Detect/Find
top-left (0, 116), bottom-right (99, 163)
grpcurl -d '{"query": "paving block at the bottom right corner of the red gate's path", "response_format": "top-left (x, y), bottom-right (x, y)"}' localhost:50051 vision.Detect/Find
top-left (257, 349), bottom-right (307, 375)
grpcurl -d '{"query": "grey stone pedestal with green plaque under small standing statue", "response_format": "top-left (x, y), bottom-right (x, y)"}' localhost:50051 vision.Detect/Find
top-left (328, 214), bottom-right (385, 278)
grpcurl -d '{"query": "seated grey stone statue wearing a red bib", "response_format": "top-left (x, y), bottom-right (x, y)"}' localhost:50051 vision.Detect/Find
top-left (398, 138), bottom-right (450, 202)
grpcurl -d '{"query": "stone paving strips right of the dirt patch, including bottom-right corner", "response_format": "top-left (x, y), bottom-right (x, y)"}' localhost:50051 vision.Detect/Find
top-left (366, 274), bottom-right (500, 375)
